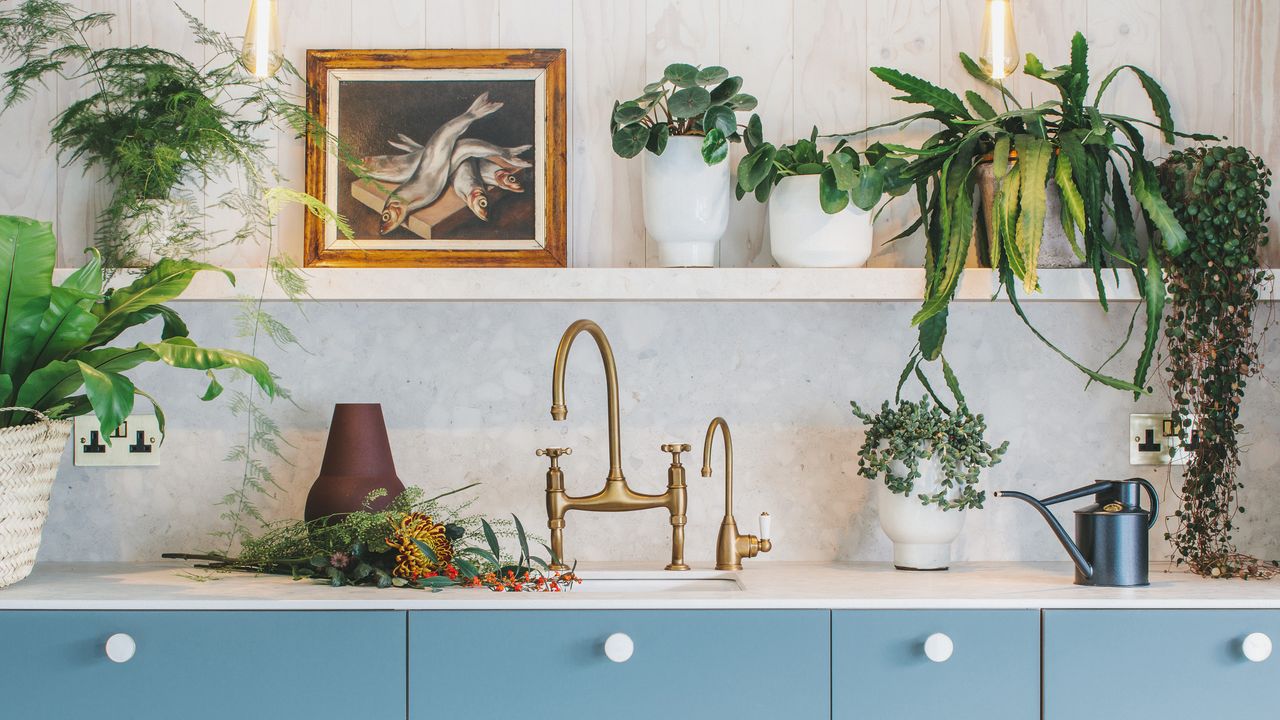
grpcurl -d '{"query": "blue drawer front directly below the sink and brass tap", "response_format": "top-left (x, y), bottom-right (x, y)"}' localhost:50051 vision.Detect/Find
top-left (408, 610), bottom-right (831, 720)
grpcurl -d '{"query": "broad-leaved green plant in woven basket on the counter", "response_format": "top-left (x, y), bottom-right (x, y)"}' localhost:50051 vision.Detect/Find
top-left (0, 215), bottom-right (275, 587)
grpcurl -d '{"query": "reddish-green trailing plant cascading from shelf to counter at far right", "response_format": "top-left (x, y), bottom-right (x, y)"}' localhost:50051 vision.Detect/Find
top-left (1157, 147), bottom-right (1280, 578)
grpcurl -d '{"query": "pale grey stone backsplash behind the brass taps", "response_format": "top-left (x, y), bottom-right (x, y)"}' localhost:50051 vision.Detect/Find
top-left (40, 302), bottom-right (1280, 566)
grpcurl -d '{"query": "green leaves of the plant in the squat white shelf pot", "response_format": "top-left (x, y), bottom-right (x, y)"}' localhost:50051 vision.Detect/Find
top-left (733, 127), bottom-right (910, 214)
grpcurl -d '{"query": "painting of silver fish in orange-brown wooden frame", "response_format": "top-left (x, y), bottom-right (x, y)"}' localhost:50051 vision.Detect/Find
top-left (305, 50), bottom-right (568, 268)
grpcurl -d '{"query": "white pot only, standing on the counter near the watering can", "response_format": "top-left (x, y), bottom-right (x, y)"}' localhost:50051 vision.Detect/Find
top-left (878, 459), bottom-right (964, 570)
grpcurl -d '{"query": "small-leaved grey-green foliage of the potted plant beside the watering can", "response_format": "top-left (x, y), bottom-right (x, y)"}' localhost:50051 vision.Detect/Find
top-left (850, 397), bottom-right (1009, 510)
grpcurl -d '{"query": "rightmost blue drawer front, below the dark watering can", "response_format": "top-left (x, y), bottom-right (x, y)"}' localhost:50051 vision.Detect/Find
top-left (1044, 610), bottom-right (1280, 720)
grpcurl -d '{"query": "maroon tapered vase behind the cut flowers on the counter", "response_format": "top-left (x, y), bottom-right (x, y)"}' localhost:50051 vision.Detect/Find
top-left (303, 402), bottom-right (404, 523)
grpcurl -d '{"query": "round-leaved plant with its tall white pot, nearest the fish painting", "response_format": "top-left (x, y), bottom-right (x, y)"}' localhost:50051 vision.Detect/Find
top-left (609, 63), bottom-right (760, 268)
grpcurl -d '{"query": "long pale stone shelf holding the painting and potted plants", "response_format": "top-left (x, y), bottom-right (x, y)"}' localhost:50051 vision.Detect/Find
top-left (49, 268), bottom-right (1182, 302)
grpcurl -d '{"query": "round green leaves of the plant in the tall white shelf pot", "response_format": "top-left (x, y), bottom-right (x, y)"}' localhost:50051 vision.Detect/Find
top-left (609, 63), bottom-right (760, 165)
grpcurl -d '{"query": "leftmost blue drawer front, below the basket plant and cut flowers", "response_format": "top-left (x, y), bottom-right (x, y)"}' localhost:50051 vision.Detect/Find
top-left (0, 611), bottom-right (406, 720)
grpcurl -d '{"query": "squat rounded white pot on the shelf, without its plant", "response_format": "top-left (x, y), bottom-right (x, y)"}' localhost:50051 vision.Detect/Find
top-left (769, 176), bottom-right (872, 268)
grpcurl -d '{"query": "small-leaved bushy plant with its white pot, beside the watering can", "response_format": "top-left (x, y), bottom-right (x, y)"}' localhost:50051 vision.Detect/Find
top-left (851, 389), bottom-right (1009, 570)
